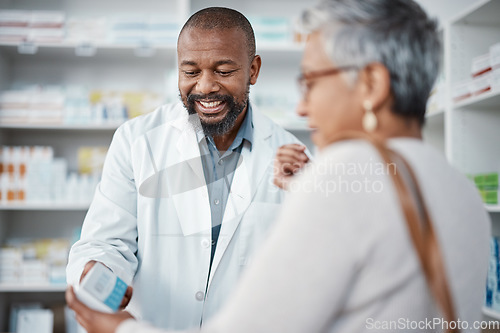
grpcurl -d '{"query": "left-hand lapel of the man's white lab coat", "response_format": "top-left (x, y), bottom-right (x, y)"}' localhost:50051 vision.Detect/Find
top-left (172, 117), bottom-right (212, 236)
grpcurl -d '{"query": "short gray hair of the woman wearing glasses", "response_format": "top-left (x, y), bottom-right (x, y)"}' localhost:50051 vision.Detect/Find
top-left (301, 0), bottom-right (441, 124)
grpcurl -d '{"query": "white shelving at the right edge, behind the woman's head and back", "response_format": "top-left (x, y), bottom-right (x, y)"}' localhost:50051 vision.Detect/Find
top-left (434, 0), bottom-right (500, 320)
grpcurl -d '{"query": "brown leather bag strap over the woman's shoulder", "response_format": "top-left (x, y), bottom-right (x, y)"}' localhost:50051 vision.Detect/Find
top-left (332, 132), bottom-right (459, 332)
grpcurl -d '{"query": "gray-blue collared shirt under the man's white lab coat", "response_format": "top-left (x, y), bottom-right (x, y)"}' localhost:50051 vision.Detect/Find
top-left (196, 104), bottom-right (253, 267)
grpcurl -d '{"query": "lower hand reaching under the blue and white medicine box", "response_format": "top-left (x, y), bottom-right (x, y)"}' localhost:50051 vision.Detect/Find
top-left (66, 286), bottom-right (134, 333)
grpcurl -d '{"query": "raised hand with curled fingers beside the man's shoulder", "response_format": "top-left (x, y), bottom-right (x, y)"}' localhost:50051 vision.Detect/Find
top-left (274, 143), bottom-right (309, 190)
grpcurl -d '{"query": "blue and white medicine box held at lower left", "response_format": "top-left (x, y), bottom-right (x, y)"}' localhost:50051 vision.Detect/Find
top-left (74, 263), bottom-right (127, 313)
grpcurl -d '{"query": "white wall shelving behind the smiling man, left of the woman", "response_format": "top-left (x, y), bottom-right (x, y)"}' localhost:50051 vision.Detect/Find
top-left (0, 0), bottom-right (312, 332)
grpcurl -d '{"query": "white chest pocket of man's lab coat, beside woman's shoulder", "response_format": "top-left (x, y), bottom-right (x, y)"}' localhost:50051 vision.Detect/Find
top-left (239, 202), bottom-right (281, 265)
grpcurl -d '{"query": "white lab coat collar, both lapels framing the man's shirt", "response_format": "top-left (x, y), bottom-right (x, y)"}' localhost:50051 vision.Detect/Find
top-left (173, 102), bottom-right (274, 278)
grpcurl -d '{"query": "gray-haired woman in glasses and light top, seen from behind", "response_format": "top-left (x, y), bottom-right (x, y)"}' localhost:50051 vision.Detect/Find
top-left (67, 0), bottom-right (490, 333)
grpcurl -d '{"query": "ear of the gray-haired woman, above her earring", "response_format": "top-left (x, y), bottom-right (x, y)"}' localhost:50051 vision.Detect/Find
top-left (360, 62), bottom-right (391, 112)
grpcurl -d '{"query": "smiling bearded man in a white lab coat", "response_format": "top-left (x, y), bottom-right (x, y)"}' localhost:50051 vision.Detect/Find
top-left (67, 8), bottom-right (308, 329)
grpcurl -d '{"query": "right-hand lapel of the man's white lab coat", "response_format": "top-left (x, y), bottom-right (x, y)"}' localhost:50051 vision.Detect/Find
top-left (209, 109), bottom-right (274, 284)
